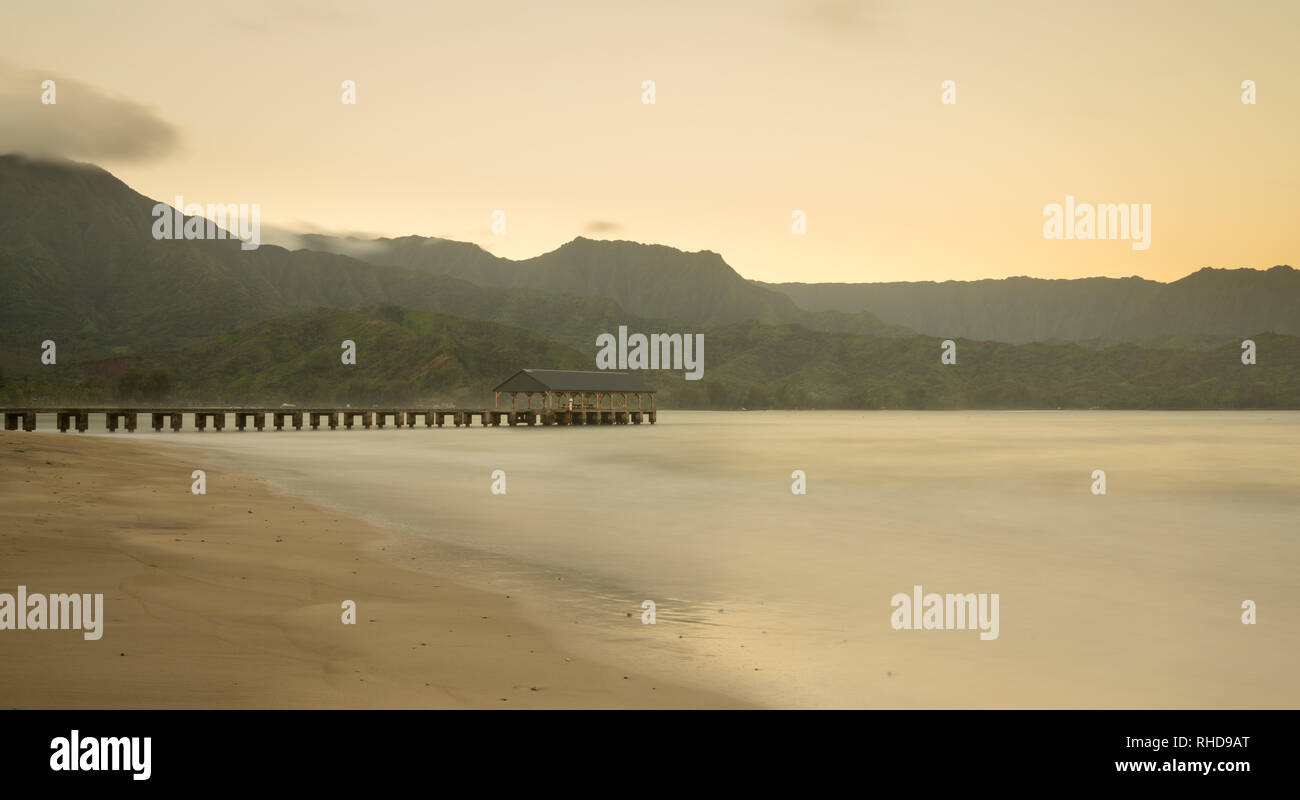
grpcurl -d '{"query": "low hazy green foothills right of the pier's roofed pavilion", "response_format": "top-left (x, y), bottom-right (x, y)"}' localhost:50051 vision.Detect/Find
top-left (676, 324), bottom-right (1300, 408)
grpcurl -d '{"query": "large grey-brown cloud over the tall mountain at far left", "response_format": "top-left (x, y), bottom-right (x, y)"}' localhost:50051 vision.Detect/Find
top-left (0, 61), bottom-right (181, 161)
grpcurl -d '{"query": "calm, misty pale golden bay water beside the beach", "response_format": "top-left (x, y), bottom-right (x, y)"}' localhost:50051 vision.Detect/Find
top-left (73, 411), bottom-right (1300, 708)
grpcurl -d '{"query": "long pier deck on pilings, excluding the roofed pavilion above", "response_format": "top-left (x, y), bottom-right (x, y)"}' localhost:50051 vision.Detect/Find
top-left (3, 406), bottom-right (658, 433)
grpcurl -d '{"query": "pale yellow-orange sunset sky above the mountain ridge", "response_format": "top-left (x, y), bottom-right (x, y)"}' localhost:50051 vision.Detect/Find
top-left (0, 0), bottom-right (1300, 282)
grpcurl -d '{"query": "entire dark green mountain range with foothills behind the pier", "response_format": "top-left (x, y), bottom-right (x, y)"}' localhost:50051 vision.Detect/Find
top-left (0, 156), bottom-right (1300, 408)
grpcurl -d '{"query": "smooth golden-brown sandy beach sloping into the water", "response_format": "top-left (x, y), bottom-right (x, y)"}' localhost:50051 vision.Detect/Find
top-left (0, 432), bottom-right (744, 709)
